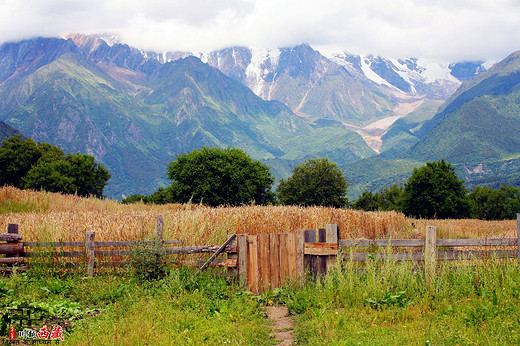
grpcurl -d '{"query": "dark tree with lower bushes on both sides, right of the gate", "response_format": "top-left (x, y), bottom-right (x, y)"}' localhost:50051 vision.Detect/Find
top-left (353, 160), bottom-right (520, 220)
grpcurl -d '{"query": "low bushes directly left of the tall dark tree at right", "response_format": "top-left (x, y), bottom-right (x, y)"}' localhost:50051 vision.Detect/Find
top-left (353, 184), bottom-right (403, 211)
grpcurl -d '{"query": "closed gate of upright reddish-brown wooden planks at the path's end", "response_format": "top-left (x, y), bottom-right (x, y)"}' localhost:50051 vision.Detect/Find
top-left (236, 225), bottom-right (338, 294)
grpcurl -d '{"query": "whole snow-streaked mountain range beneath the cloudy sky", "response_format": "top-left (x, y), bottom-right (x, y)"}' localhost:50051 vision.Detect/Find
top-left (0, 34), bottom-right (520, 198)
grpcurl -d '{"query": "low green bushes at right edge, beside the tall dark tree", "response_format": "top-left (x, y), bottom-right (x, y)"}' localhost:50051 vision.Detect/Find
top-left (468, 185), bottom-right (520, 220)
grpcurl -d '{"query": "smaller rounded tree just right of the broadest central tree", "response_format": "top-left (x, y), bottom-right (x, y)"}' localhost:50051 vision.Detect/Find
top-left (277, 158), bottom-right (348, 208)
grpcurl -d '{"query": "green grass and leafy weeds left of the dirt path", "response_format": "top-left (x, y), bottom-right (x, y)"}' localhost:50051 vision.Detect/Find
top-left (0, 268), bottom-right (272, 345)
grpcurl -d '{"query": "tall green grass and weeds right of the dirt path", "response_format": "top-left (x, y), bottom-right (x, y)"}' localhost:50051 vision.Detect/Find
top-left (286, 260), bottom-right (520, 345)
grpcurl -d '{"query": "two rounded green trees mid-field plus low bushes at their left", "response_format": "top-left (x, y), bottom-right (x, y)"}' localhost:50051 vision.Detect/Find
top-left (123, 147), bottom-right (348, 208)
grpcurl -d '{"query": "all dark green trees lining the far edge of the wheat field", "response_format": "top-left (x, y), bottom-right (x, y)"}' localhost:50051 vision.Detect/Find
top-left (0, 136), bottom-right (520, 220)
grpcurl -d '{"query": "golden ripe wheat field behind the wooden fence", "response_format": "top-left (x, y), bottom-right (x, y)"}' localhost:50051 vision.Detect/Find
top-left (0, 187), bottom-right (517, 245)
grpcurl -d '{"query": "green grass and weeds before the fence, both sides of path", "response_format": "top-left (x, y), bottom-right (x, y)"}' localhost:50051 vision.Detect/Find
top-left (4, 254), bottom-right (520, 345)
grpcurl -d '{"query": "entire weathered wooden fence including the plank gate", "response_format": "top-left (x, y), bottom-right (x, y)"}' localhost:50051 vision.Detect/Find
top-left (0, 214), bottom-right (520, 294)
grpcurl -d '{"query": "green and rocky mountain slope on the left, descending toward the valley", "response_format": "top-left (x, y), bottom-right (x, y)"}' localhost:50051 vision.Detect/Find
top-left (0, 38), bottom-right (375, 198)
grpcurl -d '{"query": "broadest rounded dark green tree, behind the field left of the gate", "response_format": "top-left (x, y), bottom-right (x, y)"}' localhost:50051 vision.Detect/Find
top-left (167, 147), bottom-right (274, 206)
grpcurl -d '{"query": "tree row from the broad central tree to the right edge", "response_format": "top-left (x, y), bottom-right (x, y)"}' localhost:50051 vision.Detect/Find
top-left (123, 148), bottom-right (520, 220)
